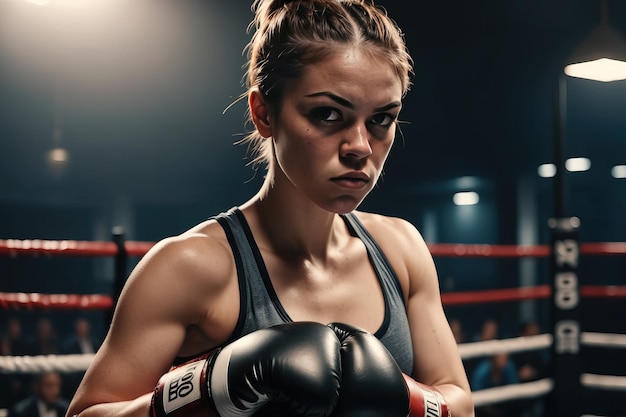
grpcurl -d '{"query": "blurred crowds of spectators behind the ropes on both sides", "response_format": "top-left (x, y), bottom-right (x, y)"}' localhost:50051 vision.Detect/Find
top-left (0, 316), bottom-right (548, 417)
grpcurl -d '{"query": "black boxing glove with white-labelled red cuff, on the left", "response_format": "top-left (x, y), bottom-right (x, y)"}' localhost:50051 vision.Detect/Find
top-left (151, 322), bottom-right (341, 417)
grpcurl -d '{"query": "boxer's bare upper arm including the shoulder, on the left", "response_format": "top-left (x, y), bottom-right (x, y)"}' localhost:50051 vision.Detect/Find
top-left (70, 234), bottom-right (233, 415)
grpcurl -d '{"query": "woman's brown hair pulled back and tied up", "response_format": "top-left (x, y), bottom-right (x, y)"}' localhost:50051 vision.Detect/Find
top-left (242, 0), bottom-right (413, 165)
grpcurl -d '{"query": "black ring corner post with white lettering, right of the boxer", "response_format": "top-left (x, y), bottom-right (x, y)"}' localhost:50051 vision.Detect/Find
top-left (546, 217), bottom-right (582, 417)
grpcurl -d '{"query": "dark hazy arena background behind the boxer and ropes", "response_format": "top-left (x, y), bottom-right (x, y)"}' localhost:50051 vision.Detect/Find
top-left (0, 0), bottom-right (626, 410)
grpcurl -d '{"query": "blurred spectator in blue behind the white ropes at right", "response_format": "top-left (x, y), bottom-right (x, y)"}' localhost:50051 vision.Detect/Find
top-left (470, 352), bottom-right (519, 417)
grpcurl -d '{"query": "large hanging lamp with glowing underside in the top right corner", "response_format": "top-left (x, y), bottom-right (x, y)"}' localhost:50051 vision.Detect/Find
top-left (565, 0), bottom-right (626, 82)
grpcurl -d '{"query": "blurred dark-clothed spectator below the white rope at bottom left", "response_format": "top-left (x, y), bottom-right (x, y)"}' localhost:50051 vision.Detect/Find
top-left (8, 371), bottom-right (69, 417)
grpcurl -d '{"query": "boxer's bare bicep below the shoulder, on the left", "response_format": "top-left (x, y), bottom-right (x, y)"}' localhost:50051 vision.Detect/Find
top-left (72, 239), bottom-right (212, 411)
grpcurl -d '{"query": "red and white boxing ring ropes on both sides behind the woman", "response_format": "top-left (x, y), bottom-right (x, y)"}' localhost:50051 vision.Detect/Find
top-left (0, 234), bottom-right (626, 417)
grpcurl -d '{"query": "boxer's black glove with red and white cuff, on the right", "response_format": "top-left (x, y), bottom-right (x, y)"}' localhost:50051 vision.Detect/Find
top-left (328, 323), bottom-right (450, 417)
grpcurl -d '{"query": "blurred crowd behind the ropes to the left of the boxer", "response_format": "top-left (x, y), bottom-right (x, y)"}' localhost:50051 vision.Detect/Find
top-left (0, 316), bottom-right (100, 417)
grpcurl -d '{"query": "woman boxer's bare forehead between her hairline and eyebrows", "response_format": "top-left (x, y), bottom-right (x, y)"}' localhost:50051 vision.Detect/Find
top-left (286, 47), bottom-right (402, 103)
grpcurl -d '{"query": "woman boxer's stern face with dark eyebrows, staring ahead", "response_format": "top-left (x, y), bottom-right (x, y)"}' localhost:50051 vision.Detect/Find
top-left (260, 48), bottom-right (402, 213)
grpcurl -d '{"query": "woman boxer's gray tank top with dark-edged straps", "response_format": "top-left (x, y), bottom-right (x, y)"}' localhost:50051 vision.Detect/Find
top-left (214, 207), bottom-right (413, 375)
